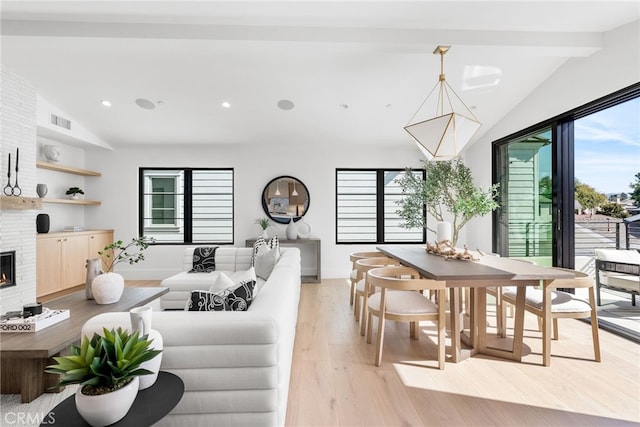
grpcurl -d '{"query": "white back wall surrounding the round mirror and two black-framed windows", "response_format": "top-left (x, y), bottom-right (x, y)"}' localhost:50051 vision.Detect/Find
top-left (85, 142), bottom-right (421, 279)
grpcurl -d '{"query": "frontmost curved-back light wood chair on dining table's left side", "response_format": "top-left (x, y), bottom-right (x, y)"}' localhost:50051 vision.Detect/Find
top-left (367, 266), bottom-right (446, 369)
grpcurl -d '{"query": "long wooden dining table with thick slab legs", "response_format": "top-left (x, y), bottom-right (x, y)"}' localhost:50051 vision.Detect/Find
top-left (377, 245), bottom-right (574, 363)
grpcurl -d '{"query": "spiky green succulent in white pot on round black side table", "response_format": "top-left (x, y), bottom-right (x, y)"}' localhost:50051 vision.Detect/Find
top-left (45, 328), bottom-right (161, 426)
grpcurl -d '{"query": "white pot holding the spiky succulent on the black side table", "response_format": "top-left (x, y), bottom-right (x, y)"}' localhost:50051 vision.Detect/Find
top-left (76, 377), bottom-right (140, 427)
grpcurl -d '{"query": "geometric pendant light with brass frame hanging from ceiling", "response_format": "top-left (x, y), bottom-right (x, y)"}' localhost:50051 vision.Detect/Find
top-left (404, 46), bottom-right (482, 160)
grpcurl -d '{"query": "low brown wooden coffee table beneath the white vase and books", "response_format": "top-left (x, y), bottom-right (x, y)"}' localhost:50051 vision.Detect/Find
top-left (0, 287), bottom-right (169, 403)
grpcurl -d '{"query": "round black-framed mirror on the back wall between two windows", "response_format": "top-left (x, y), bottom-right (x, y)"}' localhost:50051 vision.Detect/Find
top-left (262, 175), bottom-right (310, 224)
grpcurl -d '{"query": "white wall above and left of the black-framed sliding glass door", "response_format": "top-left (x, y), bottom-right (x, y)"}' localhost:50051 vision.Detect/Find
top-left (459, 21), bottom-right (640, 250)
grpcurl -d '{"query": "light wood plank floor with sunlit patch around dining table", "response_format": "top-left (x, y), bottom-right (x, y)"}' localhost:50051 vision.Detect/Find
top-left (286, 280), bottom-right (640, 426)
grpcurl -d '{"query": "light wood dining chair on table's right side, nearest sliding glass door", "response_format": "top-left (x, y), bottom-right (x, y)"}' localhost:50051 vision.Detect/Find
top-left (502, 267), bottom-right (600, 366)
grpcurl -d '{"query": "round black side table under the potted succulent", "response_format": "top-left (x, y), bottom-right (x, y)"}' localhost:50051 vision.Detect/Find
top-left (40, 371), bottom-right (184, 427)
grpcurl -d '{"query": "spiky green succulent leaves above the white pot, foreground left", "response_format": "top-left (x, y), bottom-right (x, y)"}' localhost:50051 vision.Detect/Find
top-left (45, 328), bottom-right (162, 395)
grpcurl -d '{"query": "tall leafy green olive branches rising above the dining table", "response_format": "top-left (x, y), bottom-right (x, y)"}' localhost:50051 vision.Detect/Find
top-left (396, 159), bottom-right (498, 247)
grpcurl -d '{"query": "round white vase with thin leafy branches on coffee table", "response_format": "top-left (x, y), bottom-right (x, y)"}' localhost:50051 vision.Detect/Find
top-left (91, 236), bottom-right (155, 304)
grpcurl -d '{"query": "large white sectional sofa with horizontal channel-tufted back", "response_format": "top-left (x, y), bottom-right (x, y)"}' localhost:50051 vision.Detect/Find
top-left (82, 247), bottom-right (300, 427)
